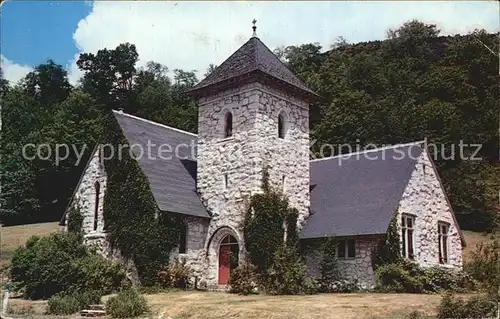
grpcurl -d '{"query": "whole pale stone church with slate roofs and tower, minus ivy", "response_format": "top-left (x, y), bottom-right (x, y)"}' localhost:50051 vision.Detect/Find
top-left (61, 30), bottom-right (465, 289)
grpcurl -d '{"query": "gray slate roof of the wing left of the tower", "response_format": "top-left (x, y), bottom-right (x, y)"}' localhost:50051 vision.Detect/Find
top-left (113, 111), bottom-right (210, 217)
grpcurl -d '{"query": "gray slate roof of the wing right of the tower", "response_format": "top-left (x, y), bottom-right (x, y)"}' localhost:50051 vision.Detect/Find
top-left (301, 143), bottom-right (422, 238)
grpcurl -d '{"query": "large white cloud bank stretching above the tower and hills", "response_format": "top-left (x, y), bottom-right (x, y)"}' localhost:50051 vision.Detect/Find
top-left (69, 1), bottom-right (499, 83)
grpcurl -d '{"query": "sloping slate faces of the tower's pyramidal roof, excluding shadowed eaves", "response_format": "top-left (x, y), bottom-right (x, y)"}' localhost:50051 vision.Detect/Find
top-left (190, 37), bottom-right (317, 95)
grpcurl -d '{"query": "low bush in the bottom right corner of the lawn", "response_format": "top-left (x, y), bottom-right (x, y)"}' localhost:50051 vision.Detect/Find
top-left (437, 293), bottom-right (496, 319)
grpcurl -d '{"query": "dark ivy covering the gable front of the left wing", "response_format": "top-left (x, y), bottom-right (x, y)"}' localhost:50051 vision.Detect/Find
top-left (103, 113), bottom-right (180, 285)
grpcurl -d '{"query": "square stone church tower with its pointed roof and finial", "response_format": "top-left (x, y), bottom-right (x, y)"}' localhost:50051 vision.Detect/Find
top-left (190, 26), bottom-right (317, 286)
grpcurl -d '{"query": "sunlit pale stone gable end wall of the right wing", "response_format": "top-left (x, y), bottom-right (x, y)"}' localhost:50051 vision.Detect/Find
top-left (398, 150), bottom-right (462, 269)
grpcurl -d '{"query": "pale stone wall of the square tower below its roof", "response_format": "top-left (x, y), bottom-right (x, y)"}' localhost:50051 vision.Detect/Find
top-left (197, 83), bottom-right (309, 285)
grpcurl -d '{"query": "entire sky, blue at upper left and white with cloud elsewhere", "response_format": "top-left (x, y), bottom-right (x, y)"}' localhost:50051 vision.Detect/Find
top-left (0, 0), bottom-right (499, 82)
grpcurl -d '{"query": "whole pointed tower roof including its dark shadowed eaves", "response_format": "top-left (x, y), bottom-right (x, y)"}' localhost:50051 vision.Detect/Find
top-left (189, 36), bottom-right (318, 98)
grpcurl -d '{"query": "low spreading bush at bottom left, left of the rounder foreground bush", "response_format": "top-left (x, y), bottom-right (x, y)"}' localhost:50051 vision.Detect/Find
top-left (48, 291), bottom-right (101, 315)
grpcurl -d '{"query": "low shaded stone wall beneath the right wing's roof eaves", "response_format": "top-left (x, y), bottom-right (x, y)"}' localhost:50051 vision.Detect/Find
top-left (305, 236), bottom-right (378, 289)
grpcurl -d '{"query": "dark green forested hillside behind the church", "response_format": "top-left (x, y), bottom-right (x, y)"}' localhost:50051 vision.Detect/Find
top-left (0, 21), bottom-right (500, 230)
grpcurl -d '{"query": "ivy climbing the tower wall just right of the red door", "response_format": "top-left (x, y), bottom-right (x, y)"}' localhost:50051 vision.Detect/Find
top-left (243, 168), bottom-right (310, 295)
